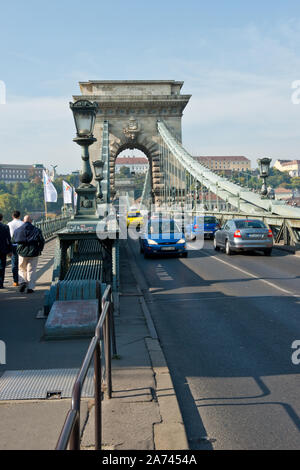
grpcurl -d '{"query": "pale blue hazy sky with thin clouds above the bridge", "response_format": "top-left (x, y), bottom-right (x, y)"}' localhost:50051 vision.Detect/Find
top-left (0, 0), bottom-right (300, 172)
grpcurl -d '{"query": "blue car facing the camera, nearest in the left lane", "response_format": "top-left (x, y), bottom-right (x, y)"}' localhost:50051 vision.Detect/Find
top-left (140, 219), bottom-right (188, 258)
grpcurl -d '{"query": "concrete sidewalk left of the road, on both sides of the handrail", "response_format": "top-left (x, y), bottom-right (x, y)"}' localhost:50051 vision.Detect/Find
top-left (0, 242), bottom-right (188, 450)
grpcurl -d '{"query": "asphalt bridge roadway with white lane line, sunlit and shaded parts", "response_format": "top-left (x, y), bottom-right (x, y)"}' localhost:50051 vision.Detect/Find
top-left (129, 240), bottom-right (300, 450)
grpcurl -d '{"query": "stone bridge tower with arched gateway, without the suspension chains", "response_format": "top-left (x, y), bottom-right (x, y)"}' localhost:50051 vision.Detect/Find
top-left (73, 80), bottom-right (191, 203)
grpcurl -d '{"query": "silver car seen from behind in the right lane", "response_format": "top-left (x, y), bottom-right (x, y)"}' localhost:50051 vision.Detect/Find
top-left (214, 219), bottom-right (273, 256)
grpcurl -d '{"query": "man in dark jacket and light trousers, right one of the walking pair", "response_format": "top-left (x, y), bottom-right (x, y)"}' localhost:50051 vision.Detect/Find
top-left (13, 215), bottom-right (45, 294)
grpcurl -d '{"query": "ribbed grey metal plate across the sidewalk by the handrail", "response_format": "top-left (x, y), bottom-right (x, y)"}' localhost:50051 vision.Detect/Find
top-left (0, 368), bottom-right (94, 400)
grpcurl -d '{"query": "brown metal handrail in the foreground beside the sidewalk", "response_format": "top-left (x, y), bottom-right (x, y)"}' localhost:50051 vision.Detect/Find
top-left (55, 285), bottom-right (113, 450)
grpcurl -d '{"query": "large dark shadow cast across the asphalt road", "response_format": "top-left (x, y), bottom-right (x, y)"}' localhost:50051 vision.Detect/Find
top-left (127, 241), bottom-right (300, 449)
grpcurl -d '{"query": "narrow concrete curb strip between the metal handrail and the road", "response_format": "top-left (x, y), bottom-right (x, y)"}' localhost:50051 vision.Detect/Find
top-left (82, 242), bottom-right (188, 450)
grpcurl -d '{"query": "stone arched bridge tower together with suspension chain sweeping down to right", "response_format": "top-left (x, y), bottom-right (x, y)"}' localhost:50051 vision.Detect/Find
top-left (73, 80), bottom-right (300, 246)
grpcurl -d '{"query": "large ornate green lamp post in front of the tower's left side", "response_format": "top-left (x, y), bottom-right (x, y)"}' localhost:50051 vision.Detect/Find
top-left (70, 100), bottom-right (98, 219)
